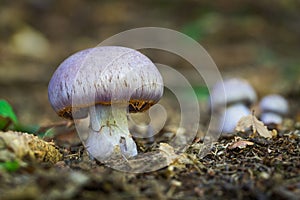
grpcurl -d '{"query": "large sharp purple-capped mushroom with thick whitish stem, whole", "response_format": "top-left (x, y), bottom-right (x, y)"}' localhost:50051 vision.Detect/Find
top-left (48, 46), bottom-right (163, 161)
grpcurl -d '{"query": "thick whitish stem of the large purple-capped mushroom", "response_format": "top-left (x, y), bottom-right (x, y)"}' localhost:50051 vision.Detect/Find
top-left (86, 105), bottom-right (137, 161)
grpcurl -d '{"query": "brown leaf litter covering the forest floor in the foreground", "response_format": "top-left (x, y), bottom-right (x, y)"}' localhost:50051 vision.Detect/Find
top-left (0, 116), bottom-right (300, 199)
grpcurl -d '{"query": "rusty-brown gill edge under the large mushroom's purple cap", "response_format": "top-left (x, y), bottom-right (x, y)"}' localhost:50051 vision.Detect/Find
top-left (58, 100), bottom-right (157, 119)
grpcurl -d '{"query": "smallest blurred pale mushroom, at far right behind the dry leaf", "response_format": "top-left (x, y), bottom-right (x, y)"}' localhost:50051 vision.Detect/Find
top-left (259, 94), bottom-right (289, 125)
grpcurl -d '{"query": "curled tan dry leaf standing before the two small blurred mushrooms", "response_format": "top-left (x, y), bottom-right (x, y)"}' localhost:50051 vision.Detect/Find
top-left (235, 113), bottom-right (272, 138)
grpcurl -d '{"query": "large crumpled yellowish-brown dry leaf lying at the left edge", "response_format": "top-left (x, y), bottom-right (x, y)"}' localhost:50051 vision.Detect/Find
top-left (0, 131), bottom-right (62, 163)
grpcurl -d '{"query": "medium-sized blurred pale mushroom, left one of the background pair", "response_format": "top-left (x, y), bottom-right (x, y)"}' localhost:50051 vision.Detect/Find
top-left (210, 78), bottom-right (257, 133)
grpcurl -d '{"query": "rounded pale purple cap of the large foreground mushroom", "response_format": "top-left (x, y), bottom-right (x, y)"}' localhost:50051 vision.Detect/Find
top-left (48, 46), bottom-right (163, 119)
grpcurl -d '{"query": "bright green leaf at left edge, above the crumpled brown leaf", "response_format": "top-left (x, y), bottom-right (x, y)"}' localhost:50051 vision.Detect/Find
top-left (0, 99), bottom-right (18, 130)
